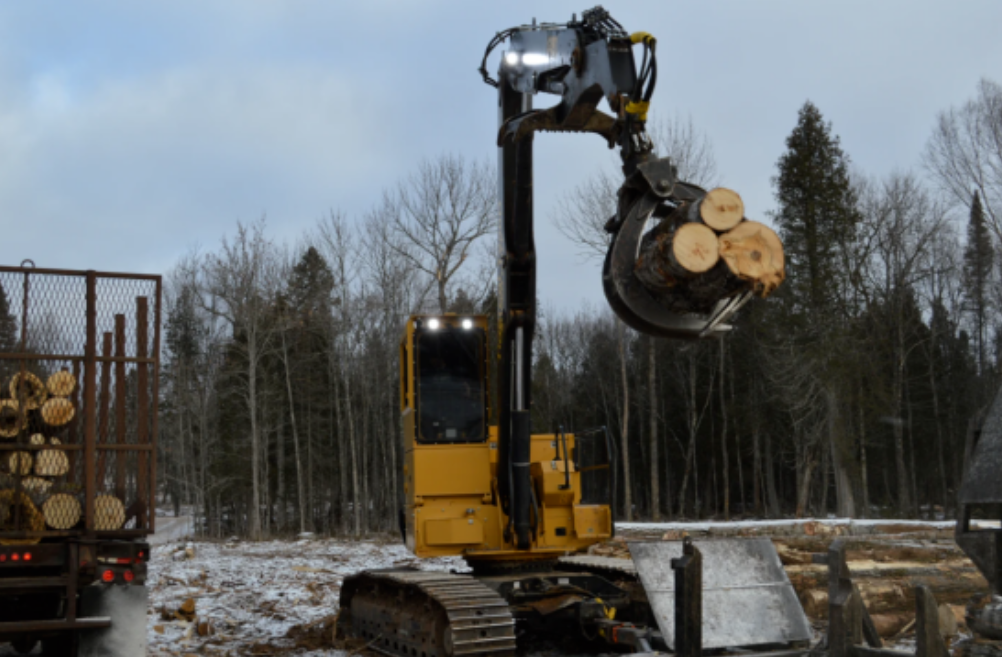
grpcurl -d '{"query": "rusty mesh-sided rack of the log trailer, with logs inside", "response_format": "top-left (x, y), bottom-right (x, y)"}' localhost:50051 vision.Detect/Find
top-left (0, 267), bottom-right (160, 543)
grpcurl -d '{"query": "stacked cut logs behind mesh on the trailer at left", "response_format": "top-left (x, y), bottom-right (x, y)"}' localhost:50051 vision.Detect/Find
top-left (0, 370), bottom-right (125, 544)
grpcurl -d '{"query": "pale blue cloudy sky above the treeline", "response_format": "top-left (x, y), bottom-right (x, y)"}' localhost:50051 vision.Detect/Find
top-left (0, 0), bottom-right (1002, 310)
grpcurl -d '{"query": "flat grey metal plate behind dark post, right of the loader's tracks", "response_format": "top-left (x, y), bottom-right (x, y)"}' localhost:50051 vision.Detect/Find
top-left (629, 539), bottom-right (812, 650)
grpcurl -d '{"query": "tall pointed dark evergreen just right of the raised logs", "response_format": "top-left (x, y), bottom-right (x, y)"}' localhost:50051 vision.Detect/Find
top-left (774, 101), bottom-right (860, 318)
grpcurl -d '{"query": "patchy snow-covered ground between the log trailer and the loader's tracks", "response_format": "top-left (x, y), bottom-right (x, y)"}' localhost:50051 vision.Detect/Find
top-left (147, 539), bottom-right (467, 655)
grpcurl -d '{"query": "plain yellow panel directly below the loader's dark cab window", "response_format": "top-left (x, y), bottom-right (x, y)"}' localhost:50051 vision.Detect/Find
top-left (413, 444), bottom-right (491, 498)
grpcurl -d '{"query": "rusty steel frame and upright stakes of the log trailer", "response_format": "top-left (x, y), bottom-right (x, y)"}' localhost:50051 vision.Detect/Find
top-left (0, 265), bottom-right (163, 540)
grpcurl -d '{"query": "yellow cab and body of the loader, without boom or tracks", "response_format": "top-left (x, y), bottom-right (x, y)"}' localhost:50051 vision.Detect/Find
top-left (400, 314), bottom-right (612, 561)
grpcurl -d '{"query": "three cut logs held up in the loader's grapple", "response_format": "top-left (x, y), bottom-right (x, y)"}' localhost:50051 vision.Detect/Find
top-left (634, 187), bottom-right (786, 313)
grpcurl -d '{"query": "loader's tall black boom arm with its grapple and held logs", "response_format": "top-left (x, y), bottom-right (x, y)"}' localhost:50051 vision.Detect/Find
top-left (480, 7), bottom-right (783, 549)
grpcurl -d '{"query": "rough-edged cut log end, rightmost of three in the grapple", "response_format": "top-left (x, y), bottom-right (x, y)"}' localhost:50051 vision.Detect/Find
top-left (719, 221), bottom-right (787, 298)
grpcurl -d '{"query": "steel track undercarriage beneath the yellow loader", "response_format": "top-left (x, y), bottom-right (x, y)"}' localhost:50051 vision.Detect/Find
top-left (338, 559), bottom-right (664, 657)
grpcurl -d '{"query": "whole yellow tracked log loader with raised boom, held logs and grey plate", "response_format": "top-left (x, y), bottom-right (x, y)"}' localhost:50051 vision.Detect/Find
top-left (338, 7), bottom-right (811, 657)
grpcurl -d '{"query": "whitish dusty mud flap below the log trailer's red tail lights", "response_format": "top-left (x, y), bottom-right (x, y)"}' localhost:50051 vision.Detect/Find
top-left (78, 583), bottom-right (149, 657)
